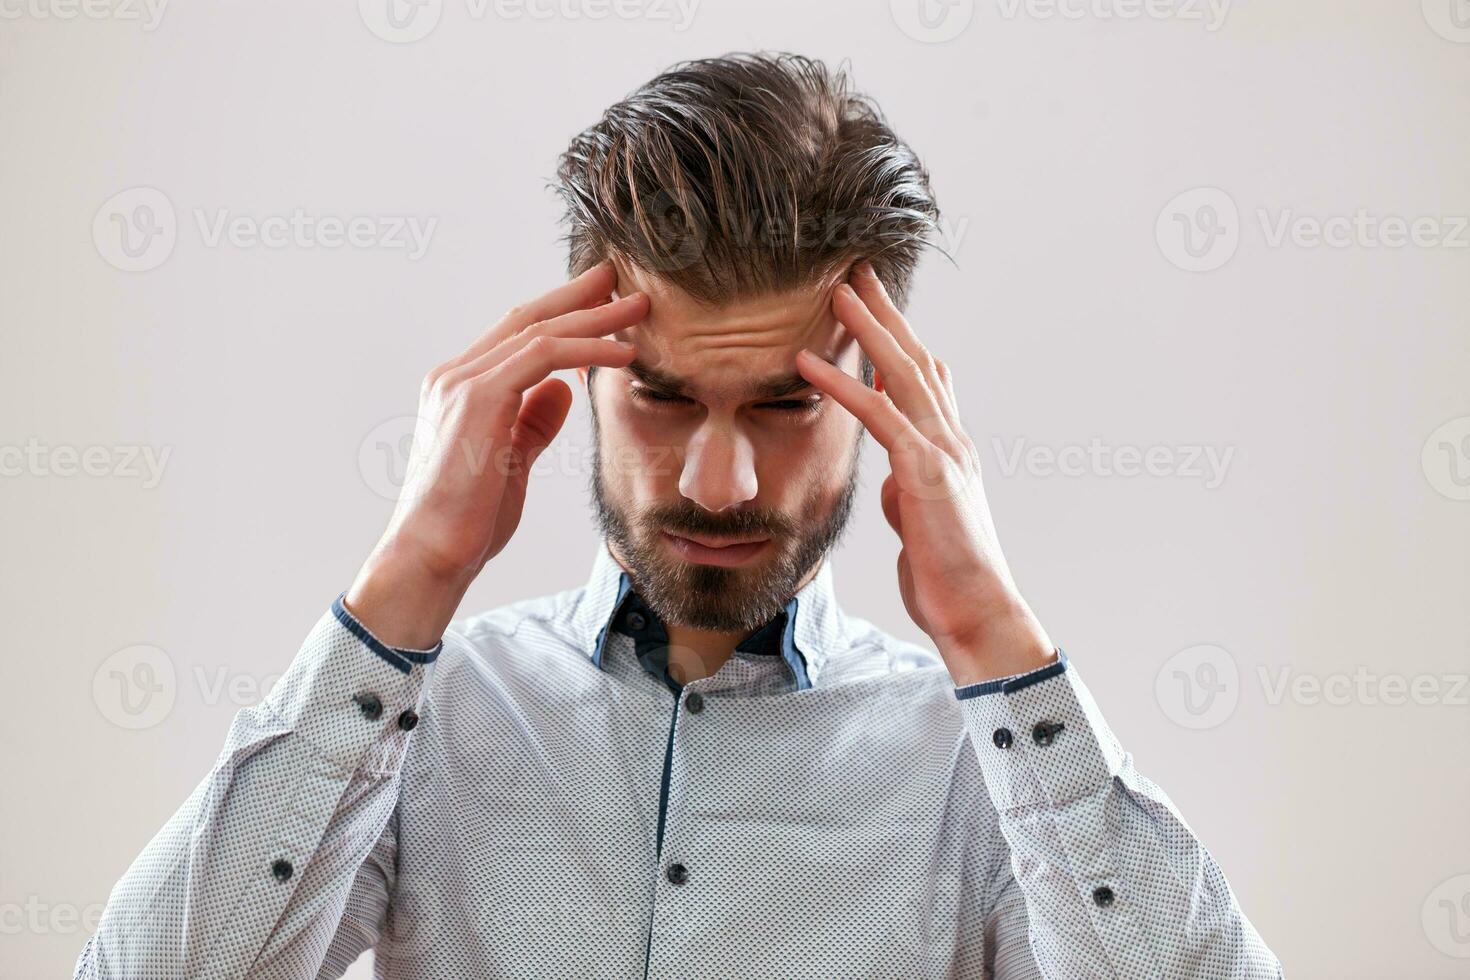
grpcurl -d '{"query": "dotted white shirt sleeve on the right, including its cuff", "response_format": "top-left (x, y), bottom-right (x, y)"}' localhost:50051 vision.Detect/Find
top-left (954, 651), bottom-right (1282, 980)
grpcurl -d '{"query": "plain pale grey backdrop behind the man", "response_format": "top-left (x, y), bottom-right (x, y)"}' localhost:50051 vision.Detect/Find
top-left (0, 0), bottom-right (1470, 979)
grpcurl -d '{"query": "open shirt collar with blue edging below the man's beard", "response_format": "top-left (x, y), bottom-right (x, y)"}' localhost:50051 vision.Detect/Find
top-left (572, 539), bottom-right (844, 691)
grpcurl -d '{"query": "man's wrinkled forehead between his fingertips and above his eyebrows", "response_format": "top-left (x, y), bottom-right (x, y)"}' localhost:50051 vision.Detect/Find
top-left (614, 259), bottom-right (857, 398)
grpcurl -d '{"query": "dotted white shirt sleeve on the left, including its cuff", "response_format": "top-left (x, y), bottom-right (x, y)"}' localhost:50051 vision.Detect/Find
top-left (75, 597), bottom-right (442, 980)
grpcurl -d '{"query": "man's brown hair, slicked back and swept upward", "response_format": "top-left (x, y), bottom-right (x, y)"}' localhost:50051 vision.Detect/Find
top-left (556, 53), bottom-right (939, 315)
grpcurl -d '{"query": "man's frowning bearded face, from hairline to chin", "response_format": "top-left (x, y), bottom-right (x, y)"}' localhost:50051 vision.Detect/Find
top-left (589, 263), bottom-right (861, 632)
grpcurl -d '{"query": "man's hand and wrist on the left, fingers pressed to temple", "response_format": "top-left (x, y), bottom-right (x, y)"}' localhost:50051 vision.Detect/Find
top-left (344, 262), bottom-right (648, 649)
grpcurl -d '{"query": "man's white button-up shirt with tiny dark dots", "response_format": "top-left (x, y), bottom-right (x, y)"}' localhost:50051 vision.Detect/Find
top-left (75, 545), bottom-right (1282, 980)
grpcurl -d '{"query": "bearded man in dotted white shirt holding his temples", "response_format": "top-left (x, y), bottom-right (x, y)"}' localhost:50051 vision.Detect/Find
top-left (76, 56), bottom-right (1280, 980)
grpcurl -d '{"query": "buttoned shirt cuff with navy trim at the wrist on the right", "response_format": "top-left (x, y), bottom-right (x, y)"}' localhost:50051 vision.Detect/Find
top-left (956, 649), bottom-right (1126, 814)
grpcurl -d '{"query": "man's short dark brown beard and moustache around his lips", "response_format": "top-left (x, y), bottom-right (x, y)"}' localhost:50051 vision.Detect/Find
top-left (592, 431), bottom-right (861, 633)
